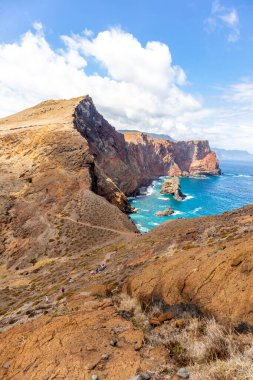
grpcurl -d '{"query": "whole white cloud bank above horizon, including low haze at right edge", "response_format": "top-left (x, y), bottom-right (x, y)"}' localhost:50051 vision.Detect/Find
top-left (0, 24), bottom-right (253, 151)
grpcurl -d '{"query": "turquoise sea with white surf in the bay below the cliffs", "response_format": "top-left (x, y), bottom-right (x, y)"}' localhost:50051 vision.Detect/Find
top-left (129, 161), bottom-right (253, 232)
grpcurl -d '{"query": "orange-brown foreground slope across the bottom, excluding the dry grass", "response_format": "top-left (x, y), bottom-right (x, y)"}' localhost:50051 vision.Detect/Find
top-left (0, 206), bottom-right (253, 380)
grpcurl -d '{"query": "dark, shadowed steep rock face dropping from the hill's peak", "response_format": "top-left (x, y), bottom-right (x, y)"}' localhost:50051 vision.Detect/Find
top-left (73, 96), bottom-right (138, 212)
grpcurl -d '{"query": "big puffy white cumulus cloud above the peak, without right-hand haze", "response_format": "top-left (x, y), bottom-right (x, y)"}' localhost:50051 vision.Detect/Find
top-left (0, 23), bottom-right (206, 134)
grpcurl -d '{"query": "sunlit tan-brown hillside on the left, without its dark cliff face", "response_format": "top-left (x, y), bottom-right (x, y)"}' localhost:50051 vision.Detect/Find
top-left (0, 99), bottom-right (135, 267)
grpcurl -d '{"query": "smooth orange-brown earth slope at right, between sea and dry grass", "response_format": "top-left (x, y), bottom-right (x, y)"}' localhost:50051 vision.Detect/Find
top-left (127, 206), bottom-right (253, 325)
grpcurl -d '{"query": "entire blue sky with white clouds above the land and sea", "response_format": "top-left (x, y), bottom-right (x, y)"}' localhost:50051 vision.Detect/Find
top-left (0, 0), bottom-right (253, 153)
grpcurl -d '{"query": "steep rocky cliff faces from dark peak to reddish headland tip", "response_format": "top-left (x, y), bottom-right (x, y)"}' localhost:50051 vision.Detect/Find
top-left (74, 96), bottom-right (220, 202)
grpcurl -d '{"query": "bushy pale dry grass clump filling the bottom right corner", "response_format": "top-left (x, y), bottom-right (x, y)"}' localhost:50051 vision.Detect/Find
top-left (146, 318), bottom-right (253, 380)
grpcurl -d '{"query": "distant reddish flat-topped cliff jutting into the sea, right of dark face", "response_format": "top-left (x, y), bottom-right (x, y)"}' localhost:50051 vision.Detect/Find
top-left (124, 132), bottom-right (220, 182)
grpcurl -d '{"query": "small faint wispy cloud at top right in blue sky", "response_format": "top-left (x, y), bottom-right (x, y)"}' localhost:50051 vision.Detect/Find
top-left (206, 0), bottom-right (240, 42)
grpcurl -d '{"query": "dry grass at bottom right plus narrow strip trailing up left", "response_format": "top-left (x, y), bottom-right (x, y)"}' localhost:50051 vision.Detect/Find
top-left (114, 294), bottom-right (253, 380)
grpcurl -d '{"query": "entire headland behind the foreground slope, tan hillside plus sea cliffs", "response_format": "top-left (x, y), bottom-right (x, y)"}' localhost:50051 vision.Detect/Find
top-left (0, 96), bottom-right (219, 266)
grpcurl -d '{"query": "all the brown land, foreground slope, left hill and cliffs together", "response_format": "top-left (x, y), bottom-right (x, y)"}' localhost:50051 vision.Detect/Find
top-left (0, 97), bottom-right (253, 380)
